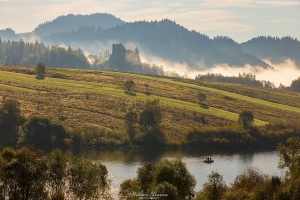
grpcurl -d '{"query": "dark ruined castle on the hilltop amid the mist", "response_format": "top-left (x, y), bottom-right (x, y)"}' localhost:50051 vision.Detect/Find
top-left (111, 44), bottom-right (141, 65)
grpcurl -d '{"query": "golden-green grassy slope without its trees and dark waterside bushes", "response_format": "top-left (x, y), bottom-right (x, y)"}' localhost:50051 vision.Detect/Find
top-left (0, 66), bottom-right (300, 144)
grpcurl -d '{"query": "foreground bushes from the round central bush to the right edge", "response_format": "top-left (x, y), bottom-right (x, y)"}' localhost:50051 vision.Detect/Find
top-left (119, 137), bottom-right (300, 200)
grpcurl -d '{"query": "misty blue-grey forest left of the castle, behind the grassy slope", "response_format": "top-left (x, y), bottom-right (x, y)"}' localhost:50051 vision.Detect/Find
top-left (0, 40), bottom-right (90, 69)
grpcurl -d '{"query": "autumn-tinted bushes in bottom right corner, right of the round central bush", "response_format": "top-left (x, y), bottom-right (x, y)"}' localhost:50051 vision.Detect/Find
top-left (195, 137), bottom-right (300, 200)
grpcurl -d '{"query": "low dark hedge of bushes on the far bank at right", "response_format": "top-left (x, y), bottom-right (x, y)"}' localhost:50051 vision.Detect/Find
top-left (186, 123), bottom-right (300, 148)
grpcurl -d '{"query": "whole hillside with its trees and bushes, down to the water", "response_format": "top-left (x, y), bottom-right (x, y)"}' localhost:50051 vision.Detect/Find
top-left (0, 66), bottom-right (300, 149)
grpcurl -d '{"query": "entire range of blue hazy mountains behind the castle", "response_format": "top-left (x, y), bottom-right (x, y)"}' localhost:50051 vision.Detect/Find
top-left (0, 13), bottom-right (300, 69)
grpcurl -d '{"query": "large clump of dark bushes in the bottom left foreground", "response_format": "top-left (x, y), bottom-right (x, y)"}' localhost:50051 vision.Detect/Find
top-left (0, 146), bottom-right (112, 200)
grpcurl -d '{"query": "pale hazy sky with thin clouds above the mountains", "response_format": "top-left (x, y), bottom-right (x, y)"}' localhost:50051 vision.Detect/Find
top-left (0, 0), bottom-right (300, 42)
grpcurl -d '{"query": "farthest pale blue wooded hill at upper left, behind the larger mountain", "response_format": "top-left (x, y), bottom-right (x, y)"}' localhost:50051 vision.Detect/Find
top-left (34, 13), bottom-right (124, 37)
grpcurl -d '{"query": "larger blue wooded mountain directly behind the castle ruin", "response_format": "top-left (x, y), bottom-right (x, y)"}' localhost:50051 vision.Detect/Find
top-left (43, 19), bottom-right (269, 68)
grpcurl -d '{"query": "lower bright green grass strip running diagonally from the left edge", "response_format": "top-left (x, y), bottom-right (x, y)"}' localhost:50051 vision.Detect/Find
top-left (0, 71), bottom-right (266, 125)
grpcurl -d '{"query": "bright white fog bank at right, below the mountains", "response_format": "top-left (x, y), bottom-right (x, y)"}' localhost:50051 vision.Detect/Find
top-left (141, 51), bottom-right (300, 87)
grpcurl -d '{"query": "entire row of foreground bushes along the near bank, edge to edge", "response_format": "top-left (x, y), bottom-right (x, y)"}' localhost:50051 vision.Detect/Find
top-left (0, 137), bottom-right (300, 200)
